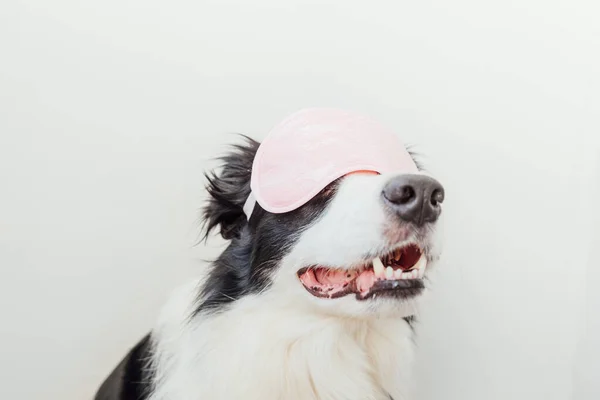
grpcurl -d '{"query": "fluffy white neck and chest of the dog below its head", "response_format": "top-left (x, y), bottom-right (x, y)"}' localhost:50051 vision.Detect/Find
top-left (149, 285), bottom-right (413, 400)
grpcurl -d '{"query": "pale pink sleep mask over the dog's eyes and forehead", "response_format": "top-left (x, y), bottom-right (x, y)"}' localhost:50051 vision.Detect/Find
top-left (244, 109), bottom-right (418, 218)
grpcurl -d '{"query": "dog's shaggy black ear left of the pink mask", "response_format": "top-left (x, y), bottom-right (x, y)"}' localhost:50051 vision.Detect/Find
top-left (202, 136), bottom-right (260, 240)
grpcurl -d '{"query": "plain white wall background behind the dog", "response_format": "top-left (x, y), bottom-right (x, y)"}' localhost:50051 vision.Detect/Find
top-left (0, 0), bottom-right (600, 400)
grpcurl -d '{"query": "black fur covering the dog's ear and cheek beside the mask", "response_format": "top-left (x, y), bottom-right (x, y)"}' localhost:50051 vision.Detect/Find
top-left (194, 139), bottom-right (337, 315)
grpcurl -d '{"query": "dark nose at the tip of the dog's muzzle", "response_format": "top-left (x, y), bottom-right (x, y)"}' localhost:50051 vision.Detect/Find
top-left (383, 175), bottom-right (444, 226)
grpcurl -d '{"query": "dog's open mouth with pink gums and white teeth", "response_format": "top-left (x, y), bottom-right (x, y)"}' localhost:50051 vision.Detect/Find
top-left (298, 244), bottom-right (427, 300)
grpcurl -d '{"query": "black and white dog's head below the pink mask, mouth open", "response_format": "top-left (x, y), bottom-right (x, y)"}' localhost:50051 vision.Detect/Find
top-left (199, 138), bottom-right (444, 317)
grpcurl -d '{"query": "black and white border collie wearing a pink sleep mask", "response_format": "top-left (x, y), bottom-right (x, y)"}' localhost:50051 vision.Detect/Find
top-left (95, 122), bottom-right (444, 400)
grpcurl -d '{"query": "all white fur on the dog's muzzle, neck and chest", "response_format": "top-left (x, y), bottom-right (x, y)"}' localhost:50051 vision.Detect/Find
top-left (150, 175), bottom-right (437, 400)
